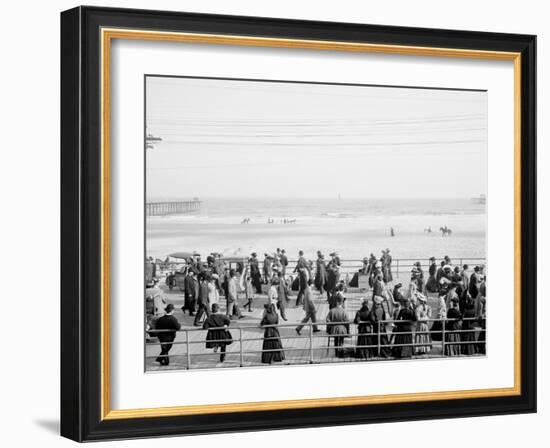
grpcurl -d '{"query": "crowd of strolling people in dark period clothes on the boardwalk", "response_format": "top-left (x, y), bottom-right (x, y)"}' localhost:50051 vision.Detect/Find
top-left (150, 249), bottom-right (486, 365)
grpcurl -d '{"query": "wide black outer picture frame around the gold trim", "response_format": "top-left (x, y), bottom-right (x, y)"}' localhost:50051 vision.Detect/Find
top-left (61, 7), bottom-right (537, 441)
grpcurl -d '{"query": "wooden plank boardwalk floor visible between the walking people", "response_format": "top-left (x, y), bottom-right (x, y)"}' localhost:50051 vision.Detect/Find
top-left (146, 280), bottom-right (470, 371)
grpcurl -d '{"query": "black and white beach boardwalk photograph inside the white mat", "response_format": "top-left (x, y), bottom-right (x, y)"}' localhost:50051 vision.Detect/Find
top-left (143, 74), bottom-right (490, 372)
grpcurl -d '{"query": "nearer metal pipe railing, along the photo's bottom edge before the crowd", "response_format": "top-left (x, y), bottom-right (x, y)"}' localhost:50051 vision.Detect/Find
top-left (145, 318), bottom-right (486, 370)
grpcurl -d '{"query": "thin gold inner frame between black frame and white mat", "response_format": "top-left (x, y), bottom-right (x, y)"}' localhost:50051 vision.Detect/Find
top-left (100, 28), bottom-right (521, 420)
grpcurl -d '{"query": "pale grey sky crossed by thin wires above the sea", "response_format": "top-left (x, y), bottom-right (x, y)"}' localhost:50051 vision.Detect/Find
top-left (146, 77), bottom-right (487, 200)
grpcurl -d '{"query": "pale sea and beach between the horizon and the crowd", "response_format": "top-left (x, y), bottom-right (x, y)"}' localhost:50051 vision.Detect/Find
top-left (146, 198), bottom-right (487, 260)
